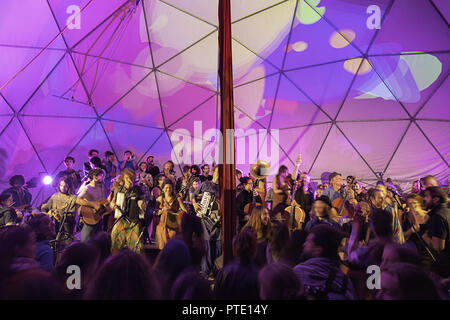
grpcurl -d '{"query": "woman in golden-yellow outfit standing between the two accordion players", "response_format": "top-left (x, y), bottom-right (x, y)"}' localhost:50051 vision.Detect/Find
top-left (155, 180), bottom-right (187, 250)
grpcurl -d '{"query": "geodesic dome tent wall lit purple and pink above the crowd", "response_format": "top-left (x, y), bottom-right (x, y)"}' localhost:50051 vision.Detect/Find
top-left (0, 0), bottom-right (450, 203)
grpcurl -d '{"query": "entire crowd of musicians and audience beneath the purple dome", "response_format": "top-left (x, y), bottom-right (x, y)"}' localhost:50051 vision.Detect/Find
top-left (0, 149), bottom-right (450, 300)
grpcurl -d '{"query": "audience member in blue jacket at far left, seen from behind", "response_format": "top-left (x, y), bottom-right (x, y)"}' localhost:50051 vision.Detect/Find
top-left (25, 213), bottom-right (56, 272)
